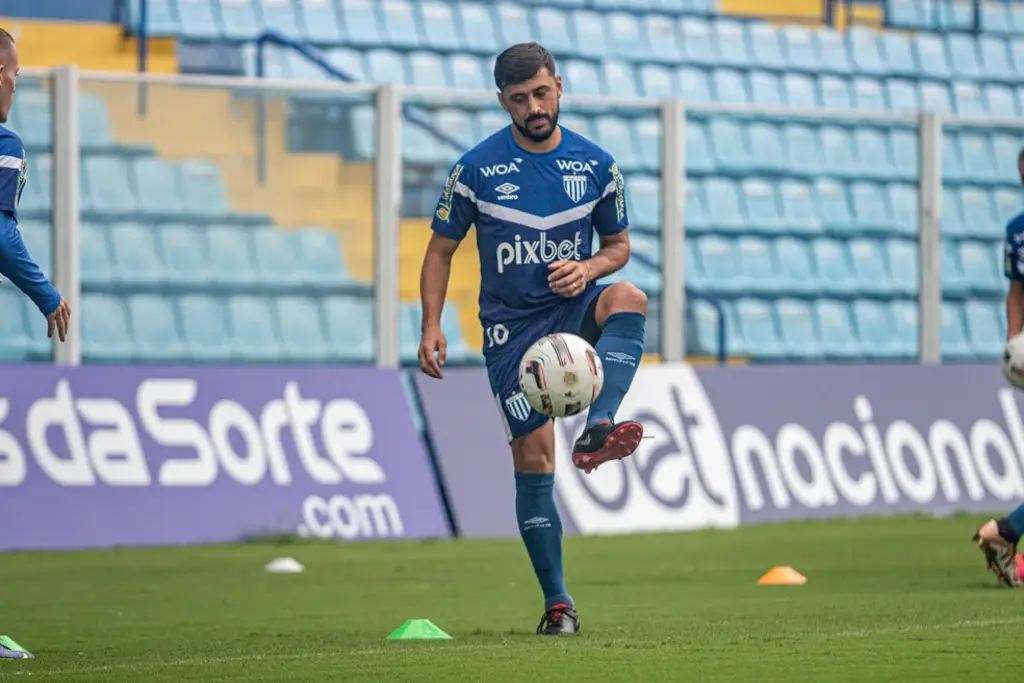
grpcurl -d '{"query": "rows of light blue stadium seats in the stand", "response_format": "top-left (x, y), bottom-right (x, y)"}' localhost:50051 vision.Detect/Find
top-left (19, 0), bottom-right (1024, 361)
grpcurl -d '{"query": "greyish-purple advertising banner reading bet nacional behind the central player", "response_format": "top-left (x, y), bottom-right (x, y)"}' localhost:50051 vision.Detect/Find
top-left (417, 365), bottom-right (1024, 536)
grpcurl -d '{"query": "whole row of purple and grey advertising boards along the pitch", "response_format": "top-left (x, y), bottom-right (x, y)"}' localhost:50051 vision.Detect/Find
top-left (0, 365), bottom-right (1024, 550)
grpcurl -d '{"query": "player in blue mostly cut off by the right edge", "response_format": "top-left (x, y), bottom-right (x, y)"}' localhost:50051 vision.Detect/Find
top-left (974, 150), bottom-right (1024, 587)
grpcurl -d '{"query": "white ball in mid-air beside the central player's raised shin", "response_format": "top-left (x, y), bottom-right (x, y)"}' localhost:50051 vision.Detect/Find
top-left (519, 333), bottom-right (604, 418)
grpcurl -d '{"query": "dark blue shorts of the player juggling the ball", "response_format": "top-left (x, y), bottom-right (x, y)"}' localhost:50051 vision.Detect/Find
top-left (483, 285), bottom-right (608, 442)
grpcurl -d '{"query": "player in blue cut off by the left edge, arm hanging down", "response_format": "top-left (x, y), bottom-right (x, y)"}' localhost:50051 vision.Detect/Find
top-left (0, 29), bottom-right (71, 341)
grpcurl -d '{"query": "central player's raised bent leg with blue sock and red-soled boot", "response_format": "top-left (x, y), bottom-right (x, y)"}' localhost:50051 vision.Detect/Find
top-left (572, 283), bottom-right (647, 472)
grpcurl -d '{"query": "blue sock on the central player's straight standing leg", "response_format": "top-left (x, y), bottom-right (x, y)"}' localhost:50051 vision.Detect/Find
top-left (515, 472), bottom-right (572, 609)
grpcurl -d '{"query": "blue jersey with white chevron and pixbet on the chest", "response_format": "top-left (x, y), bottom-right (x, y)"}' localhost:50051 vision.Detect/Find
top-left (431, 127), bottom-right (628, 326)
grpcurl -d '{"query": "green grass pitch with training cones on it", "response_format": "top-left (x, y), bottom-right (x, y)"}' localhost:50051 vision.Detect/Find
top-left (0, 516), bottom-right (1024, 683)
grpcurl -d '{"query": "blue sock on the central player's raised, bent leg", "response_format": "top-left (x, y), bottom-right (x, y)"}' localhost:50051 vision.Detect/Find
top-left (587, 313), bottom-right (647, 427)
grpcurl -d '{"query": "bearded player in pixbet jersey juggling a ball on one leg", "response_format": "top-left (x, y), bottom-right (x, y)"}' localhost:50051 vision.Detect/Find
top-left (419, 43), bottom-right (647, 635)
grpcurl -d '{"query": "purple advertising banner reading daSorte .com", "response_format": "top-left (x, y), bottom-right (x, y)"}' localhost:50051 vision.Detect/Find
top-left (0, 366), bottom-right (451, 550)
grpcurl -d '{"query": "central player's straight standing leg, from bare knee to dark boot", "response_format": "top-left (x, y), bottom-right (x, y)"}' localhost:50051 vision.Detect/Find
top-left (512, 428), bottom-right (580, 636)
